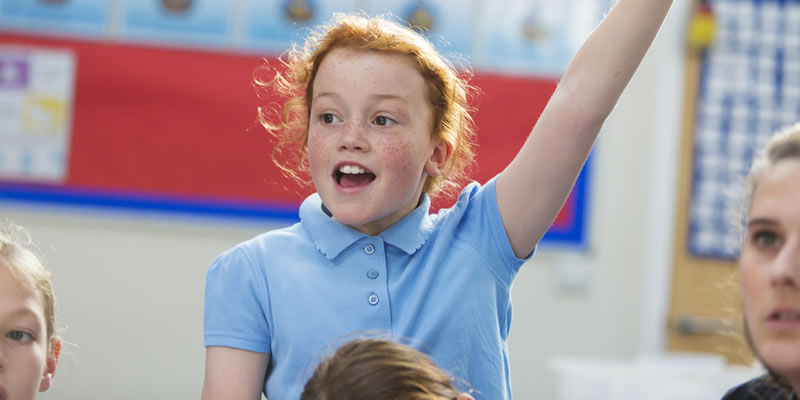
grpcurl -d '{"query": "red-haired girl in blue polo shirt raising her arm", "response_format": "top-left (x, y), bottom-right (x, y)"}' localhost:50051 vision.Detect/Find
top-left (203, 0), bottom-right (671, 400)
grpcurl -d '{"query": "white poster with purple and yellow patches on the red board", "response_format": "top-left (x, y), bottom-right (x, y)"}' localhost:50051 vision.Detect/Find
top-left (0, 46), bottom-right (76, 182)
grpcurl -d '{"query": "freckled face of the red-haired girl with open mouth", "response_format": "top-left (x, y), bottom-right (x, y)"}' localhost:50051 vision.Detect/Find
top-left (308, 48), bottom-right (446, 235)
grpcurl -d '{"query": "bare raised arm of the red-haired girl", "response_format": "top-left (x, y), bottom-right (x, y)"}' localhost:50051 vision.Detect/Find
top-left (497, 0), bottom-right (672, 257)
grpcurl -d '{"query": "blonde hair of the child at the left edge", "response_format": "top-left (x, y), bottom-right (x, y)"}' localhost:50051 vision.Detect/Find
top-left (0, 221), bottom-right (56, 350)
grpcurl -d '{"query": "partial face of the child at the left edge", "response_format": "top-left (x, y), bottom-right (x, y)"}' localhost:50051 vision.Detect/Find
top-left (0, 264), bottom-right (49, 400)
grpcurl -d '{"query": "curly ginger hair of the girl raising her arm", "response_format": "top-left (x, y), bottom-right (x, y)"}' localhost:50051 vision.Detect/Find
top-left (255, 13), bottom-right (475, 196)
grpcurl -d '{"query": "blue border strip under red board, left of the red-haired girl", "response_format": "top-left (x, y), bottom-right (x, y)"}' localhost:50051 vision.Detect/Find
top-left (0, 182), bottom-right (300, 222)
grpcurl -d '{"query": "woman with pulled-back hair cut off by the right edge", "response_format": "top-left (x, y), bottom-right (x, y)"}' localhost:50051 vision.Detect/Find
top-left (724, 124), bottom-right (800, 400)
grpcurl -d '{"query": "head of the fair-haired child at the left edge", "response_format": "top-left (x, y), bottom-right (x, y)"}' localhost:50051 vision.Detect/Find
top-left (0, 225), bottom-right (61, 400)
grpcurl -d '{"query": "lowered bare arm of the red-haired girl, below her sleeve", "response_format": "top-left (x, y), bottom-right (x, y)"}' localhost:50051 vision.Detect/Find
top-left (202, 346), bottom-right (270, 400)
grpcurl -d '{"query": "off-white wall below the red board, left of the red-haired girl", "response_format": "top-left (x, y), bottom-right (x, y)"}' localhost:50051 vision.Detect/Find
top-left (0, 211), bottom-right (278, 400)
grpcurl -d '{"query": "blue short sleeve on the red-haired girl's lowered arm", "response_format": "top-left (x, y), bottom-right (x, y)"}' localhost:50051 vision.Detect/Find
top-left (203, 247), bottom-right (271, 353)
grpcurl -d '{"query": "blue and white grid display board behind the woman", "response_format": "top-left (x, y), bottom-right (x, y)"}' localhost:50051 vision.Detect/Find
top-left (689, 0), bottom-right (800, 259)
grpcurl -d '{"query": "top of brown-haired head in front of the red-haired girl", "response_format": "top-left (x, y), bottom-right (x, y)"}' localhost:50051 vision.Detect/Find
top-left (300, 338), bottom-right (473, 400)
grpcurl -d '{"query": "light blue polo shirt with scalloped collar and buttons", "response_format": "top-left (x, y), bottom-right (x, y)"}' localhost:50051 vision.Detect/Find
top-left (204, 179), bottom-right (525, 400)
